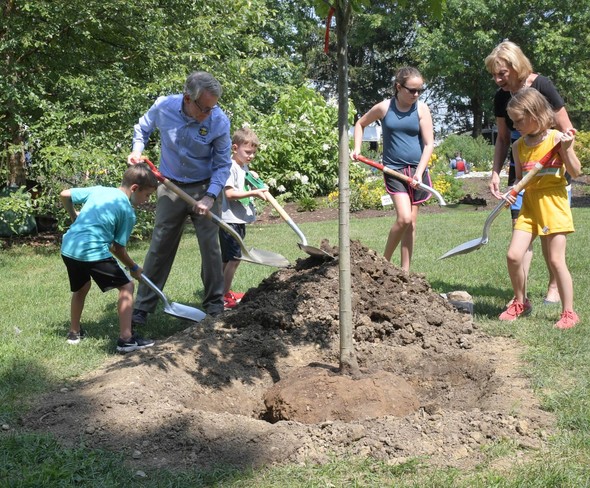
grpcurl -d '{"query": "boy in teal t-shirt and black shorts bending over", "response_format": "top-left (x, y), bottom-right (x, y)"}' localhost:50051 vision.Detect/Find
top-left (60, 163), bottom-right (158, 353)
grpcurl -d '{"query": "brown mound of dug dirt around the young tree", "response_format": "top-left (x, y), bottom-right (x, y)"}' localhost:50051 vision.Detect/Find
top-left (23, 242), bottom-right (553, 469)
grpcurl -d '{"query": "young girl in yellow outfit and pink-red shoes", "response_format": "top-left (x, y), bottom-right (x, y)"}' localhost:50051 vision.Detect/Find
top-left (500, 88), bottom-right (581, 329)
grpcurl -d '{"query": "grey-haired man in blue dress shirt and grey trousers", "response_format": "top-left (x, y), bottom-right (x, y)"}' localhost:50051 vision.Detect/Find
top-left (128, 71), bottom-right (231, 325)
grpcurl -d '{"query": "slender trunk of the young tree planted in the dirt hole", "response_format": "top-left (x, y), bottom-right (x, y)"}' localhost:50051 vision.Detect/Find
top-left (336, 0), bottom-right (360, 376)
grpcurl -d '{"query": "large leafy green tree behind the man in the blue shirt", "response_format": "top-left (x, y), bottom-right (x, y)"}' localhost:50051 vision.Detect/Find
top-left (0, 0), bottom-right (314, 233)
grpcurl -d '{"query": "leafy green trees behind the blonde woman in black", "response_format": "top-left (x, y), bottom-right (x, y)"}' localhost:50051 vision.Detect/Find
top-left (416, 0), bottom-right (590, 136)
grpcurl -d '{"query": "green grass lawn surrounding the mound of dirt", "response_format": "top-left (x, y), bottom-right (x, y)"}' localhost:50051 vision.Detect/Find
top-left (0, 208), bottom-right (590, 487)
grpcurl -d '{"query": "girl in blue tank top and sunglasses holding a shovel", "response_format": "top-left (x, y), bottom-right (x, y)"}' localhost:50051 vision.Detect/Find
top-left (352, 67), bottom-right (434, 271)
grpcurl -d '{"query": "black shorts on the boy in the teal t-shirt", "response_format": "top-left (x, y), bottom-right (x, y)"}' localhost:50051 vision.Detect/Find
top-left (61, 254), bottom-right (131, 292)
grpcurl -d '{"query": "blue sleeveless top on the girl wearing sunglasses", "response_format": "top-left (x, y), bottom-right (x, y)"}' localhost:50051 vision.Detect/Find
top-left (382, 98), bottom-right (424, 170)
